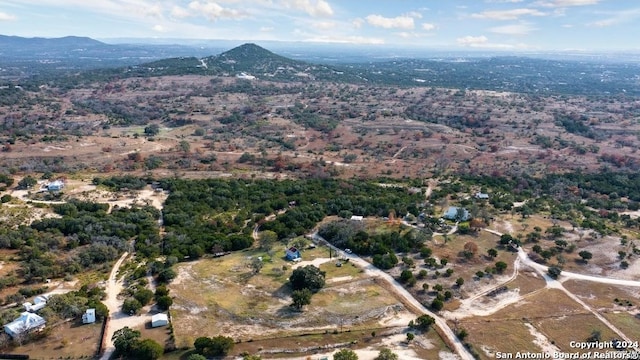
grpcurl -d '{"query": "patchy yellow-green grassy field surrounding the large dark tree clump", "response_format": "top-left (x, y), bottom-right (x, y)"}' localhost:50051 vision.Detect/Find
top-left (171, 247), bottom-right (412, 354)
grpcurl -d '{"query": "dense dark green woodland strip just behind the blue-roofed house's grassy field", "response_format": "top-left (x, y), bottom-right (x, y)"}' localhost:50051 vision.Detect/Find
top-left (153, 179), bottom-right (424, 257)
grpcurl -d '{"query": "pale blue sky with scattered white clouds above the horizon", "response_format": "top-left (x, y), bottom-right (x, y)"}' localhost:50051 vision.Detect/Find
top-left (0, 0), bottom-right (640, 51)
